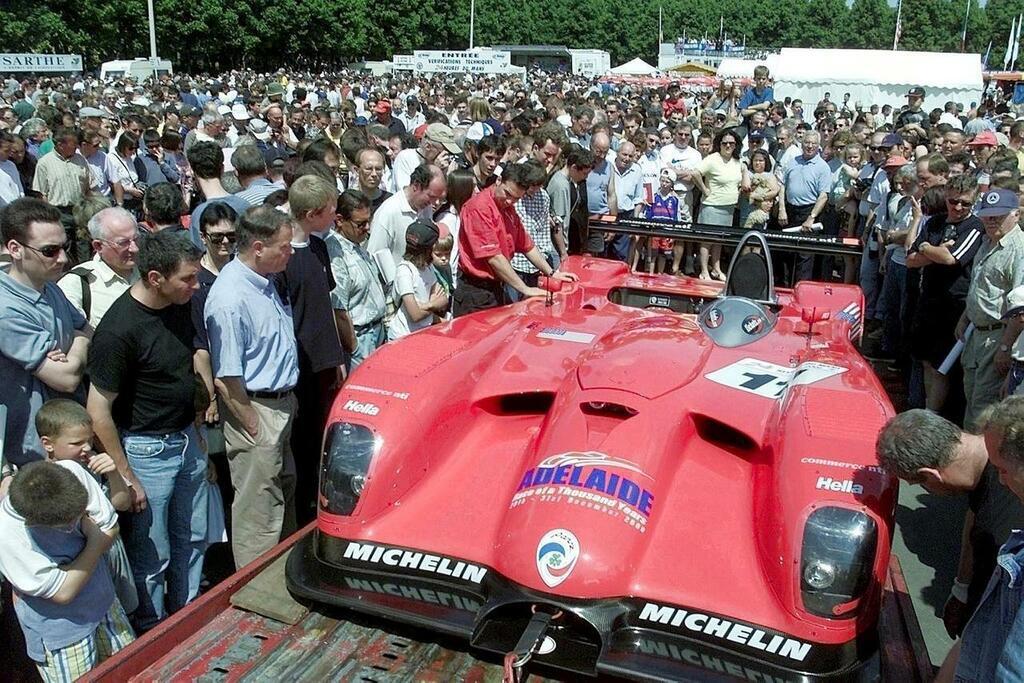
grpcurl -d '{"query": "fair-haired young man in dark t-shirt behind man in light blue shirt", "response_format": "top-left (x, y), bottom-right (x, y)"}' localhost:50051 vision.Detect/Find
top-left (274, 175), bottom-right (345, 525)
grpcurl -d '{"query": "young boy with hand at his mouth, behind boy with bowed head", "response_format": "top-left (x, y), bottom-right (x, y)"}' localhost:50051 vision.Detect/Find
top-left (36, 398), bottom-right (138, 614)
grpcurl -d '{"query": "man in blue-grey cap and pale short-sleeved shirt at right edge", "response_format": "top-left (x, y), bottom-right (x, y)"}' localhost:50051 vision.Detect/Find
top-left (956, 188), bottom-right (1024, 430)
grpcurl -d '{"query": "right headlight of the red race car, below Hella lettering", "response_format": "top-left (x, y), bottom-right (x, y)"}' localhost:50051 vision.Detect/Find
top-left (800, 507), bottom-right (878, 618)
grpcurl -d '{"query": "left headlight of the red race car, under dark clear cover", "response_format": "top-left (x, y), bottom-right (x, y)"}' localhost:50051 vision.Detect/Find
top-left (319, 422), bottom-right (377, 515)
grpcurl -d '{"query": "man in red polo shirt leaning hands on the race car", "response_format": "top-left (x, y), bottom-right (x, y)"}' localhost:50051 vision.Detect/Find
top-left (452, 163), bottom-right (578, 316)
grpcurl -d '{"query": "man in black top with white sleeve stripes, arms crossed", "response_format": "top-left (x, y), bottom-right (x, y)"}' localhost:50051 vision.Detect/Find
top-left (906, 174), bottom-right (984, 412)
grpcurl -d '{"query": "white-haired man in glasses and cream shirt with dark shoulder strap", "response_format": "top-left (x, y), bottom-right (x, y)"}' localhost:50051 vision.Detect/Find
top-left (57, 207), bottom-right (138, 329)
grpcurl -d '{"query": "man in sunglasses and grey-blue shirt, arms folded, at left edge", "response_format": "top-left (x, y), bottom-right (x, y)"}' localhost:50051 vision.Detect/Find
top-left (0, 198), bottom-right (92, 465)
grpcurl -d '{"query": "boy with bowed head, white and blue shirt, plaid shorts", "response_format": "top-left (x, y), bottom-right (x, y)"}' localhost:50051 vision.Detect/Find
top-left (0, 461), bottom-right (134, 682)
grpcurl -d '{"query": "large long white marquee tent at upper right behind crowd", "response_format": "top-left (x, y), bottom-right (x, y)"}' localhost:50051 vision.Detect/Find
top-left (768, 48), bottom-right (983, 110)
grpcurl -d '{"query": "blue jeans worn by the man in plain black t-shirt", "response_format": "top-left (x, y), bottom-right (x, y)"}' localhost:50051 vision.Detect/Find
top-left (124, 425), bottom-right (207, 631)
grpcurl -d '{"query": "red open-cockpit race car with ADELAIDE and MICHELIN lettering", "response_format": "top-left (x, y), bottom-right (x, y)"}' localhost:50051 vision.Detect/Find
top-left (288, 237), bottom-right (897, 681)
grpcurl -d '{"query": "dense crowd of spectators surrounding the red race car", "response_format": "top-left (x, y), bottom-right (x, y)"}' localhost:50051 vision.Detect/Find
top-left (0, 62), bottom-right (1024, 680)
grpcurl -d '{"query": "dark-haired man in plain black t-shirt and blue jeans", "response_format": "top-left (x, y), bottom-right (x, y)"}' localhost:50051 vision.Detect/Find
top-left (88, 231), bottom-right (207, 631)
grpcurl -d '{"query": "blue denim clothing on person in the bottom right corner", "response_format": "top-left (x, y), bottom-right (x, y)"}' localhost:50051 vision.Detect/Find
top-left (955, 530), bottom-right (1024, 683)
